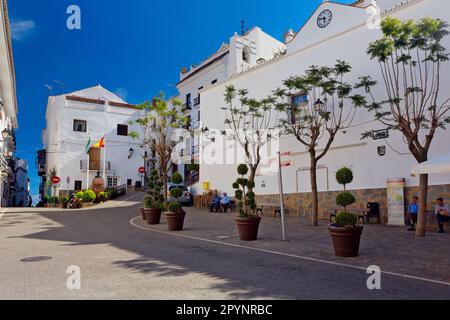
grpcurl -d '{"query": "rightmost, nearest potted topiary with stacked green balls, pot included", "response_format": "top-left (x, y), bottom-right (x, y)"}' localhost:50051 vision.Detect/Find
top-left (328, 168), bottom-right (364, 257)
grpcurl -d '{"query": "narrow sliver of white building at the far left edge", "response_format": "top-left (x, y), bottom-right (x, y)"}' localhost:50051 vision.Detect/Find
top-left (0, 0), bottom-right (17, 207)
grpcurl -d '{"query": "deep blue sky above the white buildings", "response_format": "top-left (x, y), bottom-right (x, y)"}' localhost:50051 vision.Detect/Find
top-left (8, 0), bottom-right (353, 201)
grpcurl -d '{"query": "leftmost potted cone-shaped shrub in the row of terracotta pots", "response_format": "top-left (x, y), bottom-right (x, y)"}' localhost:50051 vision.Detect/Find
top-left (142, 170), bottom-right (164, 225)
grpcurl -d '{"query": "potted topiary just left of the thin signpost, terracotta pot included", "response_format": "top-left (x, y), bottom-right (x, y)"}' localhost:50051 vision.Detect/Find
top-left (233, 164), bottom-right (261, 241)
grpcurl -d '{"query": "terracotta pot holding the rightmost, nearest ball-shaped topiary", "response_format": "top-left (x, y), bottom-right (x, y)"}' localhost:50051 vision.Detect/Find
top-left (328, 224), bottom-right (364, 258)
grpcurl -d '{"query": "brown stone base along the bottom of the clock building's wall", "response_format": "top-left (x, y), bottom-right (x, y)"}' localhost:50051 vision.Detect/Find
top-left (256, 184), bottom-right (450, 224)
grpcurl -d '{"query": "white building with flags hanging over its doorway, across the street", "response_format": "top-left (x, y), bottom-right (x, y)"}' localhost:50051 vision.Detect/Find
top-left (38, 85), bottom-right (148, 198)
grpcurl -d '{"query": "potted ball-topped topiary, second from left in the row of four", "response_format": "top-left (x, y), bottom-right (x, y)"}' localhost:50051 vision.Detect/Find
top-left (165, 172), bottom-right (186, 231)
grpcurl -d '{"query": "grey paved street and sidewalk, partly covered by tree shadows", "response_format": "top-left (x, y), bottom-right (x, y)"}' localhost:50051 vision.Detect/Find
top-left (0, 195), bottom-right (450, 299)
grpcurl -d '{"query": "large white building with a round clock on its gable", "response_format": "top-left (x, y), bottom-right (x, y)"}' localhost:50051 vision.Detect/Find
top-left (200, 0), bottom-right (450, 221)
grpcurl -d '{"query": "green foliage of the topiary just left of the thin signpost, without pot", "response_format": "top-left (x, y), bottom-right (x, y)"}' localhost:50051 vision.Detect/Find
top-left (233, 164), bottom-right (256, 218)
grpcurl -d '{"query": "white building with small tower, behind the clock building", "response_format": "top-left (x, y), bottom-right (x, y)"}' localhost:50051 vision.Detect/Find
top-left (174, 27), bottom-right (285, 192)
